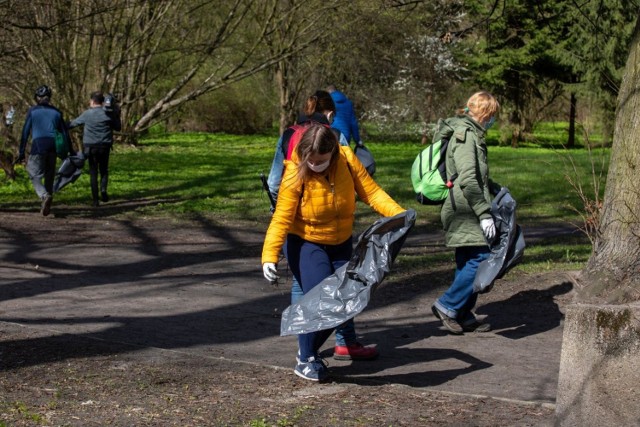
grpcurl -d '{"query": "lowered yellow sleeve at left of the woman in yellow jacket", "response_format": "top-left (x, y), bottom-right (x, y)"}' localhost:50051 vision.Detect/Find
top-left (262, 161), bottom-right (302, 264)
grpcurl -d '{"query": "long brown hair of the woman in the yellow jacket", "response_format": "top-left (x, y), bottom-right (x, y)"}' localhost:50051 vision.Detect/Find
top-left (296, 123), bottom-right (339, 180)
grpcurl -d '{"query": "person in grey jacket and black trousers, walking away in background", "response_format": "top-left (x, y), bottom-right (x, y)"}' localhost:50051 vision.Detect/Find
top-left (68, 92), bottom-right (122, 207)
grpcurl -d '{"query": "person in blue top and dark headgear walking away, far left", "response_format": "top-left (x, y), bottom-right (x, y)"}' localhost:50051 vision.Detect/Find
top-left (16, 85), bottom-right (71, 216)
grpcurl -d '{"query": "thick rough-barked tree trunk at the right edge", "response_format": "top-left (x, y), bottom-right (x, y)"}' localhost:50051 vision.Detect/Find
top-left (579, 20), bottom-right (640, 303)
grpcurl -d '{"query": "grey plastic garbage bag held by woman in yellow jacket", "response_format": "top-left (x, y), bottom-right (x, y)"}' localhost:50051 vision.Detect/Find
top-left (280, 209), bottom-right (416, 336)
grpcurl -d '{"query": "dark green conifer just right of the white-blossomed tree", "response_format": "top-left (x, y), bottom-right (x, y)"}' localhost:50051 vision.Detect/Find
top-left (460, 0), bottom-right (567, 146)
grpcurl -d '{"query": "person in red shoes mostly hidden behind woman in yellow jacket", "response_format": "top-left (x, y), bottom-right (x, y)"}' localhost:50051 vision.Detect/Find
top-left (267, 90), bottom-right (378, 360)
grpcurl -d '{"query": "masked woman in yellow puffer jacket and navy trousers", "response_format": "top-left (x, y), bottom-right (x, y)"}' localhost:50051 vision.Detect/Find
top-left (262, 124), bottom-right (404, 381)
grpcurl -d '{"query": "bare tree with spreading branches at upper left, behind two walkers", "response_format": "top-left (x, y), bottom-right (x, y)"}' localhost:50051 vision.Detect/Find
top-left (0, 0), bottom-right (316, 144)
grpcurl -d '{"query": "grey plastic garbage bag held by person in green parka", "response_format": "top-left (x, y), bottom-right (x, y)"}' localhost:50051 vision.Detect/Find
top-left (473, 187), bottom-right (525, 293)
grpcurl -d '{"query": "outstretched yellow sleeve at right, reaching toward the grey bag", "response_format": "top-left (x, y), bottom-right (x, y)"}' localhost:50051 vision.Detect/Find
top-left (344, 149), bottom-right (406, 216)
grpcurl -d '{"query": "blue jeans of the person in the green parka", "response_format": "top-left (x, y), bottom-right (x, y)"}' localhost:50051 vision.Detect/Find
top-left (435, 246), bottom-right (490, 323)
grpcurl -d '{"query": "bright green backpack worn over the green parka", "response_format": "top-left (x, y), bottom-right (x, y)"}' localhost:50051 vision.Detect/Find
top-left (411, 138), bottom-right (458, 205)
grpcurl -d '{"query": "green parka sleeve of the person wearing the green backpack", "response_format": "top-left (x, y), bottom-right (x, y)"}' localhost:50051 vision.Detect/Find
top-left (449, 130), bottom-right (491, 219)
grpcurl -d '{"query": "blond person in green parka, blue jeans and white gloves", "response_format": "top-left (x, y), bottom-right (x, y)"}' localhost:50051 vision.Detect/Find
top-left (431, 91), bottom-right (501, 335)
